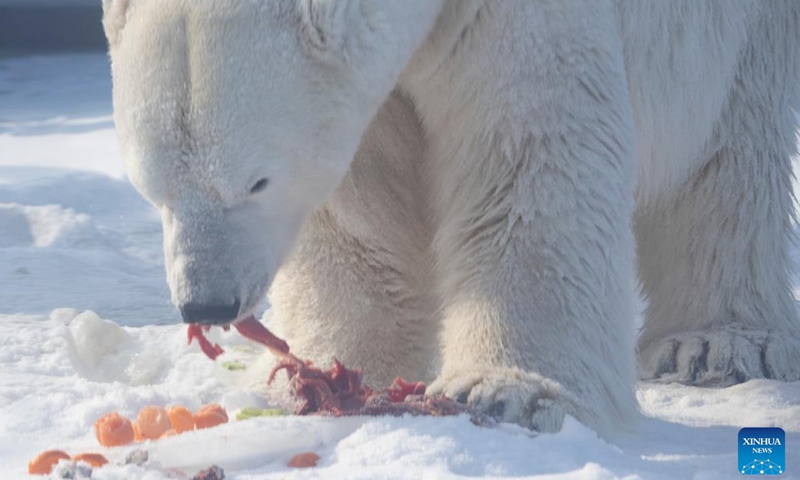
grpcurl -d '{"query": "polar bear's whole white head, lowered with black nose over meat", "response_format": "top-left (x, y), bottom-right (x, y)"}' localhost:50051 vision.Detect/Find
top-left (103, 0), bottom-right (440, 324)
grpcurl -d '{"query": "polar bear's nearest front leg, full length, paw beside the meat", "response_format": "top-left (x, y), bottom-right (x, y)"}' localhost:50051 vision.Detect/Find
top-left (405, 0), bottom-right (636, 432)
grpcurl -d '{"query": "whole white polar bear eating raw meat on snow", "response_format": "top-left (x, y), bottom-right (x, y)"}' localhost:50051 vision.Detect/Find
top-left (103, 0), bottom-right (800, 433)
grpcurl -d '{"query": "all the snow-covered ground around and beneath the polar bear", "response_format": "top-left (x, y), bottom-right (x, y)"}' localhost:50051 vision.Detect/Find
top-left (0, 55), bottom-right (800, 480)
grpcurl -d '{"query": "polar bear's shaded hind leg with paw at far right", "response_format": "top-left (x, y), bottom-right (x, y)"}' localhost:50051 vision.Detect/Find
top-left (635, 2), bottom-right (800, 385)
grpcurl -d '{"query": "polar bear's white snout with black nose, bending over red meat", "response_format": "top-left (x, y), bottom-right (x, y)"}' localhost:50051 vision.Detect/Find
top-left (161, 199), bottom-right (279, 325)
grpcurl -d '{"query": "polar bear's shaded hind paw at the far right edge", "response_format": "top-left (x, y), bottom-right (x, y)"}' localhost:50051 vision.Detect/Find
top-left (640, 327), bottom-right (800, 386)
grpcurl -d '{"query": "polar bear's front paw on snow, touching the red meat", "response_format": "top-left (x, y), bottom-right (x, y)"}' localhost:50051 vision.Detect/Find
top-left (427, 368), bottom-right (566, 433)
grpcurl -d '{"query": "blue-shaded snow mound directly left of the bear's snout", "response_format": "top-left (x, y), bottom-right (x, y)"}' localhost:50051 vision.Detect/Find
top-left (0, 166), bottom-right (173, 324)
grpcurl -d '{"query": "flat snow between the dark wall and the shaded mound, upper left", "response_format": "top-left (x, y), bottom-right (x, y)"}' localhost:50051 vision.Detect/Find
top-left (0, 54), bottom-right (122, 178)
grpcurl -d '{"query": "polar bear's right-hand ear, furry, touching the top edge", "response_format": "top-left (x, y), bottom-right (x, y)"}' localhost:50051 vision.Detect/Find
top-left (298, 0), bottom-right (352, 61)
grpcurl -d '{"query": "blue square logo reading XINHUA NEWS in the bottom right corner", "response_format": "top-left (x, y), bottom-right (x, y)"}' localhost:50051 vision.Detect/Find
top-left (739, 428), bottom-right (786, 475)
